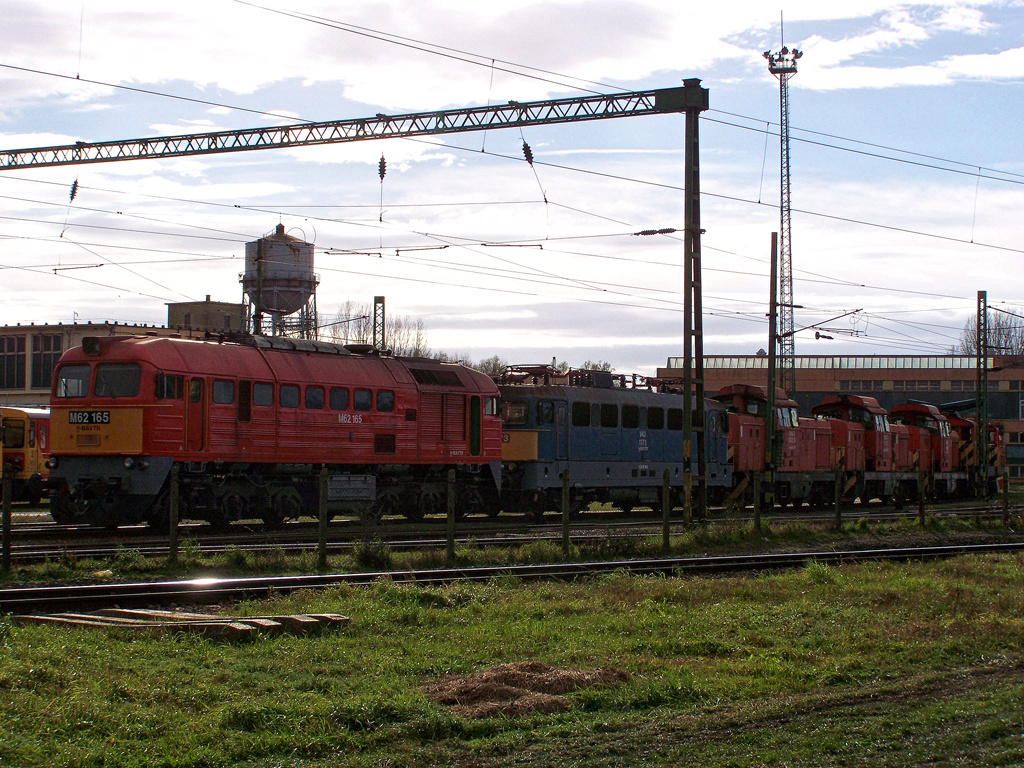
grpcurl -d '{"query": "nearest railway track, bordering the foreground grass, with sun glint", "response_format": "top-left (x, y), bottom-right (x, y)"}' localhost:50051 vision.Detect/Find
top-left (0, 542), bottom-right (1024, 614)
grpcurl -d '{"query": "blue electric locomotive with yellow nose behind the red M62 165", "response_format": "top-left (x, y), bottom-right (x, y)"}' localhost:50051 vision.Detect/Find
top-left (498, 366), bottom-right (732, 515)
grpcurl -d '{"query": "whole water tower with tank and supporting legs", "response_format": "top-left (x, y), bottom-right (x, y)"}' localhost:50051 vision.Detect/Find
top-left (241, 224), bottom-right (319, 339)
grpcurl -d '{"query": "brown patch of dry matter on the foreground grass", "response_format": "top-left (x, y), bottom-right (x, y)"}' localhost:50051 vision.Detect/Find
top-left (421, 662), bottom-right (630, 718)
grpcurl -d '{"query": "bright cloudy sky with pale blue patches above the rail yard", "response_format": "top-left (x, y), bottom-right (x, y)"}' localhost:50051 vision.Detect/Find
top-left (0, 0), bottom-right (1024, 374)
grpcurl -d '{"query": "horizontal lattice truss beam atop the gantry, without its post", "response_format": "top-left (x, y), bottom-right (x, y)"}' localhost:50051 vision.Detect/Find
top-left (0, 86), bottom-right (708, 171)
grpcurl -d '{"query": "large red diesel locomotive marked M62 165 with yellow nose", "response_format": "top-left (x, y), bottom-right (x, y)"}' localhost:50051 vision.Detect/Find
top-left (49, 336), bottom-right (502, 526)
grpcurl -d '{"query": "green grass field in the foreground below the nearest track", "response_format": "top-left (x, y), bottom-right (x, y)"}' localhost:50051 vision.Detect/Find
top-left (0, 544), bottom-right (1024, 768)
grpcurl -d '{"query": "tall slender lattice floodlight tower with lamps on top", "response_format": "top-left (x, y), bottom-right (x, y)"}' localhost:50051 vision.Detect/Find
top-left (764, 45), bottom-right (804, 392)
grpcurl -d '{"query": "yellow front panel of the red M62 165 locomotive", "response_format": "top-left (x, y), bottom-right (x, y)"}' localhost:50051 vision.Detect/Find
top-left (50, 408), bottom-right (142, 456)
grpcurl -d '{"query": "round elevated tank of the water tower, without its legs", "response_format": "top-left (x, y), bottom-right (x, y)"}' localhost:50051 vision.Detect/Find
top-left (242, 224), bottom-right (317, 315)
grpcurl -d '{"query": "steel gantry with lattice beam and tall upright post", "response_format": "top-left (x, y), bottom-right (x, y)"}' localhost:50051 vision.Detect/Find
top-left (0, 78), bottom-right (709, 514)
